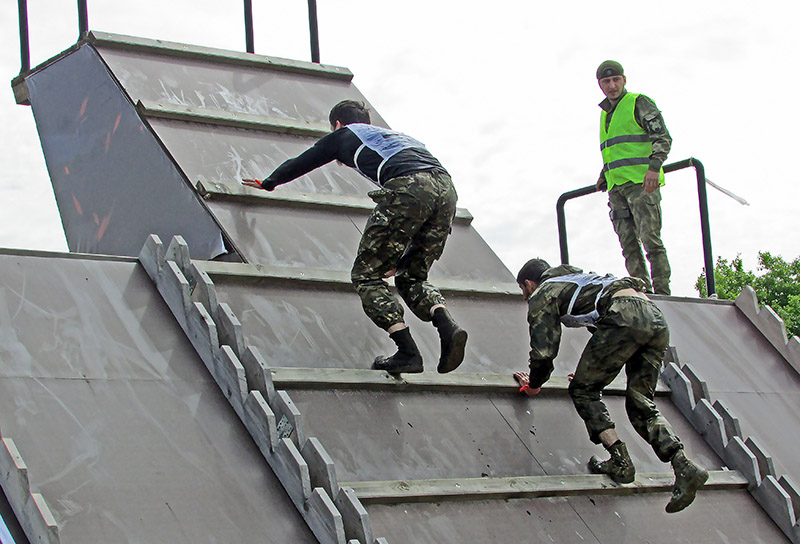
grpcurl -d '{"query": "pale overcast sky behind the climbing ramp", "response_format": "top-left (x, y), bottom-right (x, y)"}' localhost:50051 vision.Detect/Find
top-left (0, 0), bottom-right (800, 296)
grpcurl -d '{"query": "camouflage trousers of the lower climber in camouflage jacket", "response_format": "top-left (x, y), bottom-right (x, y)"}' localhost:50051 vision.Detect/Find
top-left (569, 297), bottom-right (683, 462)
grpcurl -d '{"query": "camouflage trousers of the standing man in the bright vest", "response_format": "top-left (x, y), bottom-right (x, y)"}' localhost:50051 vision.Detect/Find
top-left (608, 182), bottom-right (670, 295)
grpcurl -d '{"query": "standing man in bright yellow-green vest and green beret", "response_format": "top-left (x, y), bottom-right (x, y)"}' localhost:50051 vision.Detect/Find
top-left (597, 60), bottom-right (672, 295)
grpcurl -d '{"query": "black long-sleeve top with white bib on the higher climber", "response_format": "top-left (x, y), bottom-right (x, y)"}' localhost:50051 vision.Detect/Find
top-left (261, 126), bottom-right (447, 189)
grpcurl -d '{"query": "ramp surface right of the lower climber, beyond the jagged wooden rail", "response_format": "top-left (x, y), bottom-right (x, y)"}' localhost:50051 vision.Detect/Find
top-left (657, 299), bottom-right (800, 481)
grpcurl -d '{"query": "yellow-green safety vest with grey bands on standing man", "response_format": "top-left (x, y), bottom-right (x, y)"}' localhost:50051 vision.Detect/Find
top-left (600, 93), bottom-right (664, 189)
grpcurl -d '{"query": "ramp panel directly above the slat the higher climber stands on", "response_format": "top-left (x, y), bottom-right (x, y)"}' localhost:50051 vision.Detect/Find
top-left (209, 280), bottom-right (588, 376)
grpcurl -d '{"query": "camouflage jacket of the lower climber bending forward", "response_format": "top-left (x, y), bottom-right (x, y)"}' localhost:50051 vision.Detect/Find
top-left (528, 265), bottom-right (645, 388)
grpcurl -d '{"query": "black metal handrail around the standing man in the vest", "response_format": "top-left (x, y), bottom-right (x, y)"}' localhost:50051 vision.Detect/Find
top-left (556, 157), bottom-right (717, 297)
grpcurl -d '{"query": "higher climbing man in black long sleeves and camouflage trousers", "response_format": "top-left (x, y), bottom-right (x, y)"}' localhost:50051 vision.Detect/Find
top-left (242, 100), bottom-right (467, 374)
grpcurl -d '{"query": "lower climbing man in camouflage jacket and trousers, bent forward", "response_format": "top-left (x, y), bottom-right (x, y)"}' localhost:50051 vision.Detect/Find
top-left (514, 259), bottom-right (708, 512)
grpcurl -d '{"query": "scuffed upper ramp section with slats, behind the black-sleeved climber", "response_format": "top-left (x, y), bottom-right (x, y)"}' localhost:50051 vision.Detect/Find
top-left (89, 35), bottom-right (513, 281)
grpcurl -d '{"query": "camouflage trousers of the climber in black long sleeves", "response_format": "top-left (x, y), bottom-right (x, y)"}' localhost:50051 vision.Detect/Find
top-left (350, 172), bottom-right (458, 330)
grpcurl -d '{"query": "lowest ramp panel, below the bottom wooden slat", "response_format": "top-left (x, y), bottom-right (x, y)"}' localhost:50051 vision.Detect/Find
top-left (367, 491), bottom-right (788, 544)
